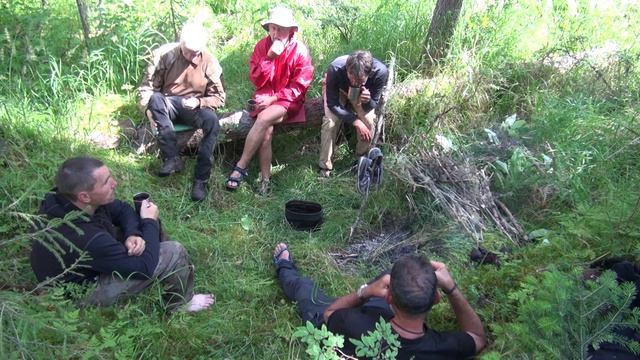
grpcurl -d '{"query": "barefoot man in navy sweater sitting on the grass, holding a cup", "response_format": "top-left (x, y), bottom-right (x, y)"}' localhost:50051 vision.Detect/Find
top-left (31, 157), bottom-right (214, 311)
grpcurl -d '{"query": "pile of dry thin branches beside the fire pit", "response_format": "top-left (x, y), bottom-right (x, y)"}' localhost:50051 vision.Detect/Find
top-left (400, 150), bottom-right (526, 245)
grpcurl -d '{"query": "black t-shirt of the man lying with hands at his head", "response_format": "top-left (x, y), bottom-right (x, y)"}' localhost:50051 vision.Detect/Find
top-left (327, 306), bottom-right (476, 360)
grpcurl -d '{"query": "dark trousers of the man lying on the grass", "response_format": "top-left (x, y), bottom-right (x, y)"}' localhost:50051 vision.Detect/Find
top-left (276, 260), bottom-right (391, 328)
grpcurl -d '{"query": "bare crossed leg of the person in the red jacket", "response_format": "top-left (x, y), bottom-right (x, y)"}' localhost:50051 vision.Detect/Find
top-left (227, 105), bottom-right (287, 187)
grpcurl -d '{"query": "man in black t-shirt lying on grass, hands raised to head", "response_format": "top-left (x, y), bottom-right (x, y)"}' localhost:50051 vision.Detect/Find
top-left (273, 243), bottom-right (486, 359)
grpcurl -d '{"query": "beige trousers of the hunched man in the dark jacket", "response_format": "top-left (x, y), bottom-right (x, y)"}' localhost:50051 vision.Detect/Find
top-left (318, 85), bottom-right (376, 170)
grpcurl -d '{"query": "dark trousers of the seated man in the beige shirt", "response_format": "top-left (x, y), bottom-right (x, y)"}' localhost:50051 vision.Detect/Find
top-left (147, 92), bottom-right (220, 180)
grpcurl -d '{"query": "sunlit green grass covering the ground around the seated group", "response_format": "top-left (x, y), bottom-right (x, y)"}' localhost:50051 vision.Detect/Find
top-left (0, 0), bottom-right (640, 359)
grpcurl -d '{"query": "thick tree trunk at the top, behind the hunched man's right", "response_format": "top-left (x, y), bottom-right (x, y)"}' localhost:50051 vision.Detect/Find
top-left (424, 0), bottom-right (462, 71)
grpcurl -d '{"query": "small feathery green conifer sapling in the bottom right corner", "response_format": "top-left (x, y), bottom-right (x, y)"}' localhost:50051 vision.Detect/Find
top-left (496, 270), bottom-right (640, 359)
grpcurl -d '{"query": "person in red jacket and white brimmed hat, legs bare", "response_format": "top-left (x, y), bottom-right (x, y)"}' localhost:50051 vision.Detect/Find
top-left (226, 7), bottom-right (313, 194)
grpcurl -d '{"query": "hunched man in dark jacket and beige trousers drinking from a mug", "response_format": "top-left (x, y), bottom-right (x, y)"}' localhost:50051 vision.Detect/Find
top-left (318, 50), bottom-right (389, 177)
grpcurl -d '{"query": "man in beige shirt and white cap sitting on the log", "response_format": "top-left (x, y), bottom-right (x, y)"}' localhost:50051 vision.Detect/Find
top-left (138, 24), bottom-right (225, 201)
